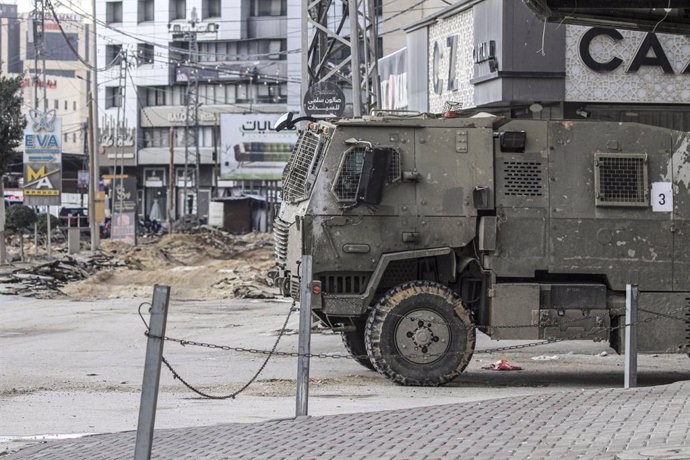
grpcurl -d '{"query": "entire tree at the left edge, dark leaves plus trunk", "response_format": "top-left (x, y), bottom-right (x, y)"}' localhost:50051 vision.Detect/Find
top-left (0, 75), bottom-right (26, 265)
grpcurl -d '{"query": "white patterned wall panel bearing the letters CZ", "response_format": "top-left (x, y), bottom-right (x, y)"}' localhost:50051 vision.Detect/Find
top-left (428, 8), bottom-right (474, 113)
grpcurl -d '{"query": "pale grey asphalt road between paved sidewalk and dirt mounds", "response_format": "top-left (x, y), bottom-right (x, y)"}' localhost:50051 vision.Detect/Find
top-left (0, 296), bottom-right (690, 454)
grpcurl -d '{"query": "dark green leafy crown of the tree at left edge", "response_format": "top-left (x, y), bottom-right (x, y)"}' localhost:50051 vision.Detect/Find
top-left (0, 76), bottom-right (26, 176)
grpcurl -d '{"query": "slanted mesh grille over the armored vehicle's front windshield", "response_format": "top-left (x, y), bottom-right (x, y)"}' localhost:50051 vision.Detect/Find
top-left (283, 131), bottom-right (323, 203)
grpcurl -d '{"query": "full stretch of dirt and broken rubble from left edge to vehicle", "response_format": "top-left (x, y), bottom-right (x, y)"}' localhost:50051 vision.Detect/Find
top-left (0, 227), bottom-right (276, 300)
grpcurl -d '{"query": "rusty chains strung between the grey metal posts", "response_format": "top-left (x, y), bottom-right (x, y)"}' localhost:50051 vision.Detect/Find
top-left (139, 301), bottom-right (689, 400)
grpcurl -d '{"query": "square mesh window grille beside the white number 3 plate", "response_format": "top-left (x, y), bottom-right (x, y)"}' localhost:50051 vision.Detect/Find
top-left (594, 153), bottom-right (649, 207)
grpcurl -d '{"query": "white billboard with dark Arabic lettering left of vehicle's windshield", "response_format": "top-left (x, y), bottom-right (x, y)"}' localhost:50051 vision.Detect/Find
top-left (220, 114), bottom-right (297, 180)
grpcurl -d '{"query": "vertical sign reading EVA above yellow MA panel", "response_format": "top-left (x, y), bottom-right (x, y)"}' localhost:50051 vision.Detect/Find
top-left (23, 109), bottom-right (62, 206)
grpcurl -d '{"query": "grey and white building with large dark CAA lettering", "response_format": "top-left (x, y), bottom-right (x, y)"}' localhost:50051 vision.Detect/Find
top-left (396, 0), bottom-right (690, 131)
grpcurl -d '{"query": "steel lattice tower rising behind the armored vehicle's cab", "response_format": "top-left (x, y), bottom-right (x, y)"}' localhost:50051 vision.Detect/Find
top-left (301, 0), bottom-right (380, 117)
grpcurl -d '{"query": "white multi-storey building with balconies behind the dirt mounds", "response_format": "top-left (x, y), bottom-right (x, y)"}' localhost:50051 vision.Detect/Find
top-left (97, 0), bottom-right (292, 225)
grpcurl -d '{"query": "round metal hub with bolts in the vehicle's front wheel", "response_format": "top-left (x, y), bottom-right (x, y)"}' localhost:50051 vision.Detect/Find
top-left (395, 309), bottom-right (450, 364)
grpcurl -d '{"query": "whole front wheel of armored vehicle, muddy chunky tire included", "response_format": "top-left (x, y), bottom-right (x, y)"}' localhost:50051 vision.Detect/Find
top-left (364, 281), bottom-right (476, 386)
